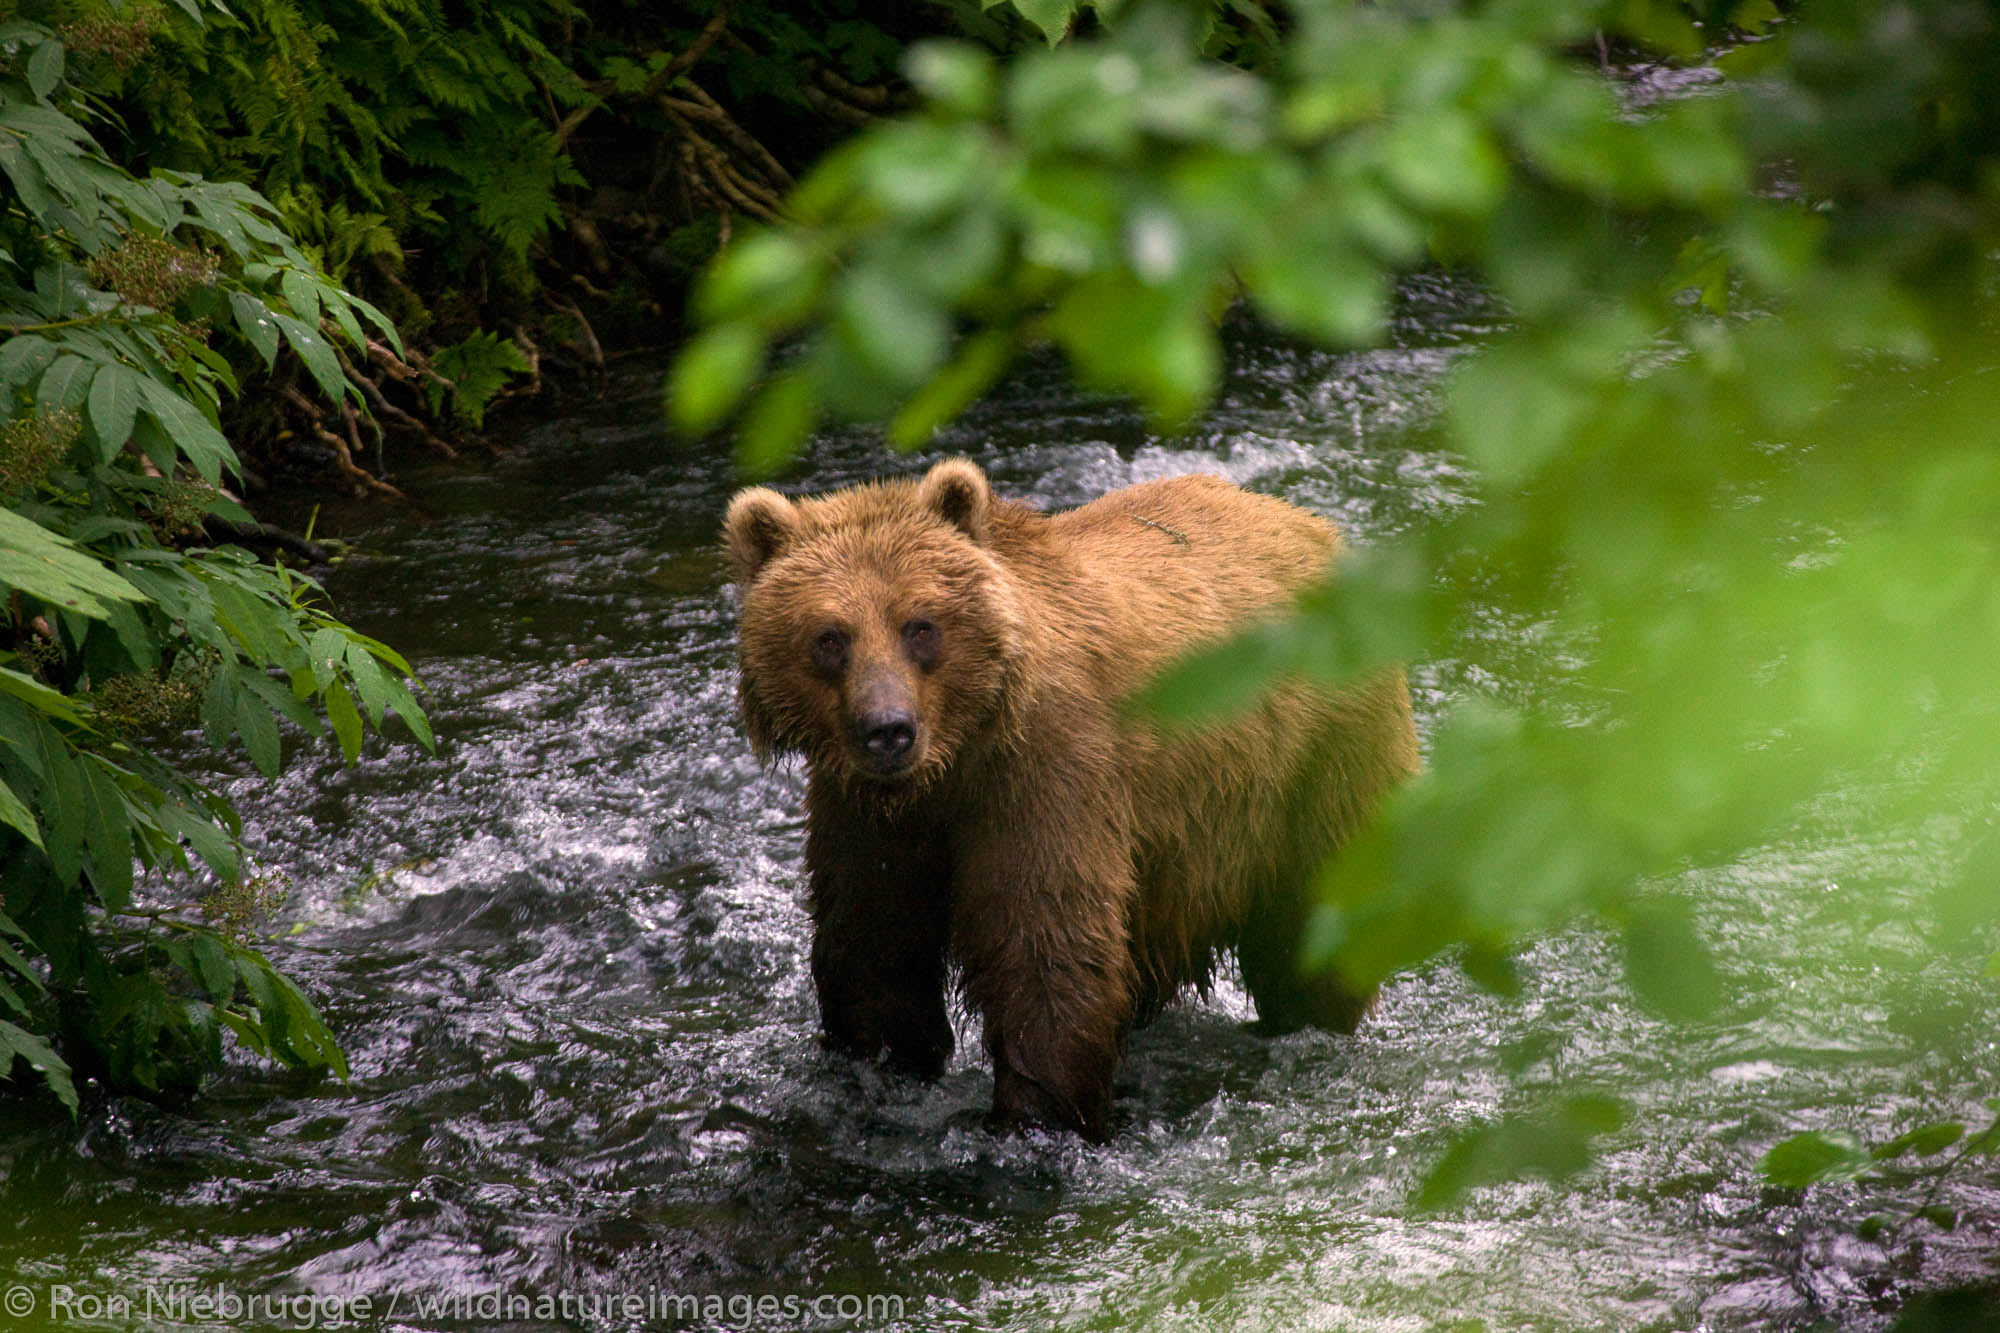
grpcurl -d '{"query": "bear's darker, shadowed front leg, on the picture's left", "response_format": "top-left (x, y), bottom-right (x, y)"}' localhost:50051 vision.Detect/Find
top-left (806, 783), bottom-right (952, 1079)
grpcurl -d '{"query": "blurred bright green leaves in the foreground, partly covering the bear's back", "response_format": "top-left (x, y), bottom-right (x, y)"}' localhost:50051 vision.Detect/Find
top-left (670, 0), bottom-right (2000, 1203)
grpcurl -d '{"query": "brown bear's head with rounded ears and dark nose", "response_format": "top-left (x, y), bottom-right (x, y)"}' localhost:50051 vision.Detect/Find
top-left (724, 458), bottom-right (1022, 795)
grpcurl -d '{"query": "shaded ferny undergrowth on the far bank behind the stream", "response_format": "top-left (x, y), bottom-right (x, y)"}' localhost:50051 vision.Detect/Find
top-left (86, 0), bottom-right (1024, 352)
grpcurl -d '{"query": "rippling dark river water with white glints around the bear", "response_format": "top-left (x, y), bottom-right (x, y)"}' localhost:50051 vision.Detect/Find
top-left (0, 280), bottom-right (2000, 1333)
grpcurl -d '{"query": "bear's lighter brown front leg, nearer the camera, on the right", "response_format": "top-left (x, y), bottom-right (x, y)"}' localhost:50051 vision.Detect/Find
top-left (952, 785), bottom-right (1138, 1143)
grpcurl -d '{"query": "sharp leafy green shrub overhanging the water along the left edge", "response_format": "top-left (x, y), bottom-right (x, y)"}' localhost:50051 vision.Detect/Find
top-left (0, 6), bottom-right (428, 1109)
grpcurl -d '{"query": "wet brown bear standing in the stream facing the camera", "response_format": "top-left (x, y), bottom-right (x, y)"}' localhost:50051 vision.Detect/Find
top-left (724, 458), bottom-right (1418, 1141)
